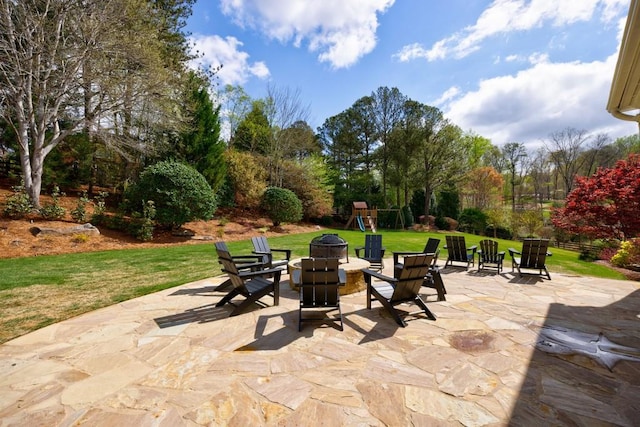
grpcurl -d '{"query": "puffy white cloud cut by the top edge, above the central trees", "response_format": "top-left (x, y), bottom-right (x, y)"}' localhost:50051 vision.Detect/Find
top-left (221, 0), bottom-right (395, 68)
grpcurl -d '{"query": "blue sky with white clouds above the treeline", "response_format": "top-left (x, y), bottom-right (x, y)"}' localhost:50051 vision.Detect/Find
top-left (186, 0), bottom-right (638, 148)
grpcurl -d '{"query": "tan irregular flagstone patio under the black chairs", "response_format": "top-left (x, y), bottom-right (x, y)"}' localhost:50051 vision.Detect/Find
top-left (0, 262), bottom-right (640, 426)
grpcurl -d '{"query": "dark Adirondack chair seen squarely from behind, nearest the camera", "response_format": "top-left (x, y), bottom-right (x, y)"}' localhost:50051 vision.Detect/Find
top-left (292, 258), bottom-right (347, 331)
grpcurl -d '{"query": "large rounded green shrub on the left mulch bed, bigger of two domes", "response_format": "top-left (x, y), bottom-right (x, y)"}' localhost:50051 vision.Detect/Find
top-left (125, 161), bottom-right (216, 228)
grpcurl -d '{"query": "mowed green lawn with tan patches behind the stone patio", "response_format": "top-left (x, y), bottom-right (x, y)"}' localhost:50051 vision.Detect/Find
top-left (0, 230), bottom-right (624, 343)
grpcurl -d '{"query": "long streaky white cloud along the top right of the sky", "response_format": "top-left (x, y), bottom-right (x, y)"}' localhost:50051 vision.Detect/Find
top-left (394, 0), bottom-right (628, 61)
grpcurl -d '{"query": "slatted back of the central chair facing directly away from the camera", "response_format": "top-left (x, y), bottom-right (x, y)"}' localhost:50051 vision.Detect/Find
top-left (300, 258), bottom-right (340, 307)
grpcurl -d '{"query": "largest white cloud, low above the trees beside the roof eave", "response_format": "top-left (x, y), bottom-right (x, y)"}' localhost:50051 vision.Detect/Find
top-left (445, 54), bottom-right (636, 146)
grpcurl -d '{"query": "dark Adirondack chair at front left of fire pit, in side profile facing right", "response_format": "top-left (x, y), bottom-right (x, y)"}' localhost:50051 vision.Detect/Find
top-left (216, 249), bottom-right (282, 316)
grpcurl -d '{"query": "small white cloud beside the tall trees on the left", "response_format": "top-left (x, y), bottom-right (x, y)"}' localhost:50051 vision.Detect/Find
top-left (191, 35), bottom-right (269, 85)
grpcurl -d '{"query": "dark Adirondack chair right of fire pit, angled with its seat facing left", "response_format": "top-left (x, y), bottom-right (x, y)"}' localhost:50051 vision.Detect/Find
top-left (362, 254), bottom-right (436, 328)
